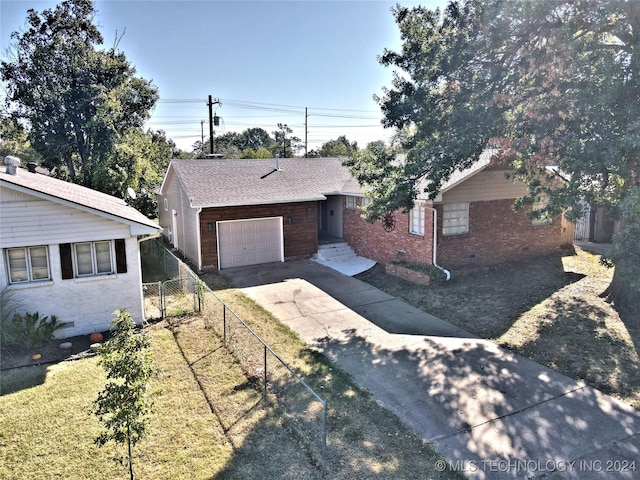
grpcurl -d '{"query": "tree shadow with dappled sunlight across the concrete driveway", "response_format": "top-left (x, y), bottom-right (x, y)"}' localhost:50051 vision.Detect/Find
top-left (310, 331), bottom-right (640, 476)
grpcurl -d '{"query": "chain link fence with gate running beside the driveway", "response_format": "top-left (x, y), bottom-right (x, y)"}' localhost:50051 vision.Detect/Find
top-left (143, 241), bottom-right (328, 472)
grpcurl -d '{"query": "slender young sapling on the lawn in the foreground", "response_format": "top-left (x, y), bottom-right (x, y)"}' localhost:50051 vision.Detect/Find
top-left (93, 310), bottom-right (154, 480)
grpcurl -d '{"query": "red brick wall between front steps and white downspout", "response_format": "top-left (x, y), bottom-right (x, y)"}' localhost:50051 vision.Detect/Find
top-left (343, 199), bottom-right (433, 265)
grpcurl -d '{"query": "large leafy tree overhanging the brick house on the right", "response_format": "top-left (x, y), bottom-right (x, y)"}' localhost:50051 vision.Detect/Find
top-left (351, 0), bottom-right (640, 312)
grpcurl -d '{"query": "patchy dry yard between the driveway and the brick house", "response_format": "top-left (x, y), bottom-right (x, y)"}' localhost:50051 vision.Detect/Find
top-left (358, 248), bottom-right (640, 408)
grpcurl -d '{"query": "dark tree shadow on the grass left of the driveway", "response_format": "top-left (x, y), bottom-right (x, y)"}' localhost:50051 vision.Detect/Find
top-left (213, 344), bottom-right (462, 480)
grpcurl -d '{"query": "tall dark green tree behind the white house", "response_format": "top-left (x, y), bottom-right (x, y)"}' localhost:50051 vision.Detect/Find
top-left (0, 0), bottom-right (158, 193)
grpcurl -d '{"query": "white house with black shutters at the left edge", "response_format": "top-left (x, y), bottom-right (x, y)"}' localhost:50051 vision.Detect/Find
top-left (0, 158), bottom-right (160, 338)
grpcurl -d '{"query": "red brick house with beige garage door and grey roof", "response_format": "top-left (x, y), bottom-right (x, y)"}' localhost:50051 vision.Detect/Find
top-left (158, 155), bottom-right (573, 276)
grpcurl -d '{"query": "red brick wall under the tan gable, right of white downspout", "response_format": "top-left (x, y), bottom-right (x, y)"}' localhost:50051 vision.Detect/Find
top-left (436, 200), bottom-right (563, 269)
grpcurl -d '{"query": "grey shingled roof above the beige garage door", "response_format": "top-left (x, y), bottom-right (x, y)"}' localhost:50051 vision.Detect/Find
top-left (165, 158), bottom-right (360, 207)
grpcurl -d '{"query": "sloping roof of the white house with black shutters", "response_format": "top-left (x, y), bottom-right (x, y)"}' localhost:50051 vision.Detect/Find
top-left (0, 168), bottom-right (160, 233)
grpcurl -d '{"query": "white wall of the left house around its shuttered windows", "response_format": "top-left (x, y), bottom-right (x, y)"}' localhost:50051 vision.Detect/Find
top-left (0, 189), bottom-right (143, 338)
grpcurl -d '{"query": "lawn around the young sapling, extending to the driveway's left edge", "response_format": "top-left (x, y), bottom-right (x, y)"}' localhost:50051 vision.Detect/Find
top-left (0, 284), bottom-right (460, 480)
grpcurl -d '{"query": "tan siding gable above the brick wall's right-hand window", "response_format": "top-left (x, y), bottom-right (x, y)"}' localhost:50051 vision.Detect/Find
top-left (442, 170), bottom-right (527, 203)
